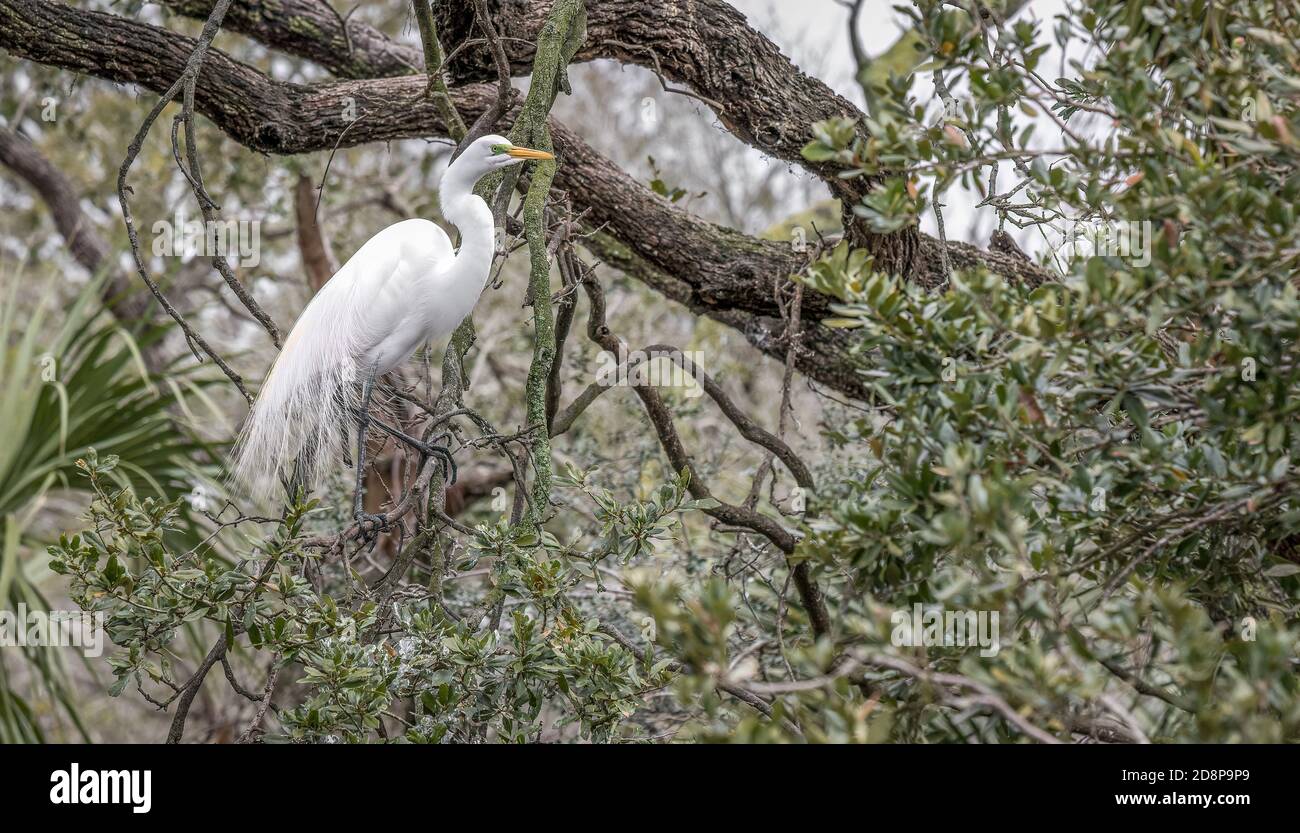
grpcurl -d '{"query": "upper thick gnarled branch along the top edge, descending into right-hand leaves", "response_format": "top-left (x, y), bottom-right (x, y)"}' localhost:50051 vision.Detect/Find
top-left (149, 0), bottom-right (1044, 285)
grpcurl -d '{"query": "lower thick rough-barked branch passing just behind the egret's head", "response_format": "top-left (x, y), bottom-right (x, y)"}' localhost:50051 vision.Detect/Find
top-left (0, 0), bottom-right (863, 396)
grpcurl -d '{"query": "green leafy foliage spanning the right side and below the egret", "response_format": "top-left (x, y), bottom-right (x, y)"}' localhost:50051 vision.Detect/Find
top-left (35, 0), bottom-right (1300, 742)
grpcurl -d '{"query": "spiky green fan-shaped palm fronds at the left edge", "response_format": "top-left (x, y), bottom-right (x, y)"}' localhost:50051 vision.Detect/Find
top-left (0, 266), bottom-right (221, 743)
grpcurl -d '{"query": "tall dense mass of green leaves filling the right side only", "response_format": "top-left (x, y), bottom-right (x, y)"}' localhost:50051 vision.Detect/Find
top-left (785, 3), bottom-right (1300, 741)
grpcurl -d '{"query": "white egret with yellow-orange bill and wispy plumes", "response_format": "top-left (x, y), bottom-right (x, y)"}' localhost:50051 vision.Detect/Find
top-left (231, 135), bottom-right (554, 500)
